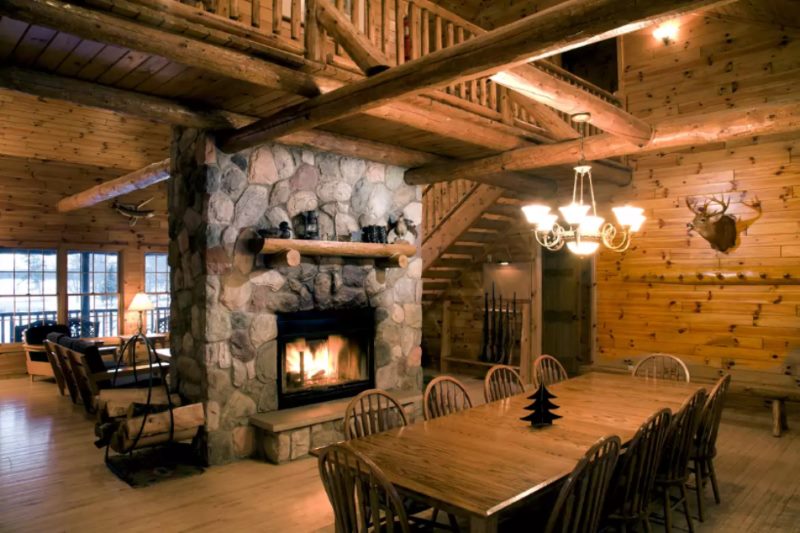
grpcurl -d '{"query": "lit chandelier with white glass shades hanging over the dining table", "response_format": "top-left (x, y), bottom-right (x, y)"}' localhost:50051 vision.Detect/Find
top-left (522, 113), bottom-right (645, 256)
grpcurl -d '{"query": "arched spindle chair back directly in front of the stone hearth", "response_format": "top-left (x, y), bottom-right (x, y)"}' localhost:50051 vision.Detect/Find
top-left (344, 389), bottom-right (408, 440)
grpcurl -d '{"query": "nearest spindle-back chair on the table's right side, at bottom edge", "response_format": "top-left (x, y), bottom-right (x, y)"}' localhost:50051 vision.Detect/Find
top-left (545, 435), bottom-right (620, 533)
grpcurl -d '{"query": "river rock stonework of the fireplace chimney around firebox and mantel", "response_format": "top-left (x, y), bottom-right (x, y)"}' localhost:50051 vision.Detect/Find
top-left (169, 128), bottom-right (422, 464)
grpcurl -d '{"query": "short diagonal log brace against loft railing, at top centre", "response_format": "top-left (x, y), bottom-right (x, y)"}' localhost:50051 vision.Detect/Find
top-left (316, 0), bottom-right (389, 76)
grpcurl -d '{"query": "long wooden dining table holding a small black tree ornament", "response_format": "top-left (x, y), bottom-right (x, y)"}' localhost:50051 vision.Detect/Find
top-left (340, 372), bottom-right (703, 532)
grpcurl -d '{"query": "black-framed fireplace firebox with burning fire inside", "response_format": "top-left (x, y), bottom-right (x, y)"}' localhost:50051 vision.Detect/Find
top-left (277, 308), bottom-right (375, 409)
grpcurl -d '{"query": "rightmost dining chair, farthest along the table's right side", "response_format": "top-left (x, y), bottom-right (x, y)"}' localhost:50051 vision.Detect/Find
top-left (692, 374), bottom-right (731, 522)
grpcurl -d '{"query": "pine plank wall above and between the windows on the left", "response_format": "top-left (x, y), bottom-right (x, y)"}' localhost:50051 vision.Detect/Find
top-left (0, 91), bottom-right (169, 377)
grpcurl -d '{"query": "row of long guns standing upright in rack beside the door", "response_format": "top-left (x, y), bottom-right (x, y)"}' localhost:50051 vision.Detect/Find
top-left (480, 283), bottom-right (517, 365)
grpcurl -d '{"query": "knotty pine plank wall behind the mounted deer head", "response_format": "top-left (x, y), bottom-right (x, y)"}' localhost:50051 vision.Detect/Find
top-left (597, 11), bottom-right (800, 373)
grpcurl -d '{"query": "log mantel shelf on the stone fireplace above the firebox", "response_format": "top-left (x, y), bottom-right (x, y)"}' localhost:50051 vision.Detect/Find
top-left (261, 239), bottom-right (417, 268)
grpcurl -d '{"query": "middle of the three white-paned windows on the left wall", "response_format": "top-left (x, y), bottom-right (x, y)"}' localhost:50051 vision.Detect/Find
top-left (67, 252), bottom-right (119, 337)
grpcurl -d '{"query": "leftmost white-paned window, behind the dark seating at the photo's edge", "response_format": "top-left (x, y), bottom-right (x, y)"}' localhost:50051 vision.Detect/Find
top-left (0, 249), bottom-right (58, 342)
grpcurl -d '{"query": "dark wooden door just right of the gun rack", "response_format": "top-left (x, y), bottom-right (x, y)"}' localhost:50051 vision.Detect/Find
top-left (542, 249), bottom-right (593, 375)
